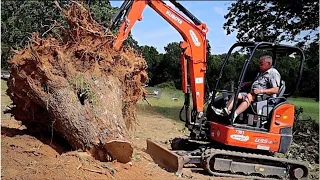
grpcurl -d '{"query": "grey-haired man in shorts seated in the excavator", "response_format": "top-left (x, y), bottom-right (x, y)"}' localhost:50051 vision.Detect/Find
top-left (212, 55), bottom-right (281, 122)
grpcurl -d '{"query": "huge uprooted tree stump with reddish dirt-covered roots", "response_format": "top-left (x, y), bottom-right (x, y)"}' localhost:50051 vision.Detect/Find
top-left (7, 2), bottom-right (147, 163)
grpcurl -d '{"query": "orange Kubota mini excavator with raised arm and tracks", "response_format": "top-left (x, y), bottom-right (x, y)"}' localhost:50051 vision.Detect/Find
top-left (109, 0), bottom-right (309, 179)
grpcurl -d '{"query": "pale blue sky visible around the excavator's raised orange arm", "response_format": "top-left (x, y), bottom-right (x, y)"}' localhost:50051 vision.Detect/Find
top-left (110, 0), bottom-right (236, 54)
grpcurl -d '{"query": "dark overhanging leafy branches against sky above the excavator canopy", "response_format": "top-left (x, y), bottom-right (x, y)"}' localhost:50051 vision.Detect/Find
top-left (223, 0), bottom-right (319, 45)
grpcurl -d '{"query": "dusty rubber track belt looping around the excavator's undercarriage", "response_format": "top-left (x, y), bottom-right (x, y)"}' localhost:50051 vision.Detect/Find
top-left (201, 149), bottom-right (309, 180)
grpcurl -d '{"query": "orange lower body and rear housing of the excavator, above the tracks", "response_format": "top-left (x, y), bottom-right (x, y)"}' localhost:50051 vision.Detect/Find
top-left (210, 103), bottom-right (294, 152)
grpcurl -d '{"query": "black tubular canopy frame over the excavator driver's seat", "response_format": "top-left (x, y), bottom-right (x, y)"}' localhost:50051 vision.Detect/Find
top-left (213, 42), bottom-right (305, 99)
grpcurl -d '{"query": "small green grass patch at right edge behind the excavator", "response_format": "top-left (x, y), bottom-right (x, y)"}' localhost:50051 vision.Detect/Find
top-left (289, 98), bottom-right (319, 121)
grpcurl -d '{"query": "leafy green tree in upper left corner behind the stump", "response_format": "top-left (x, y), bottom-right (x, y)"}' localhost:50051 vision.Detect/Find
top-left (1, 1), bottom-right (64, 68)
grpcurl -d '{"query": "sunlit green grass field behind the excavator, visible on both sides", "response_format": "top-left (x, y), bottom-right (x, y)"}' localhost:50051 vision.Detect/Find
top-left (138, 88), bottom-right (319, 121)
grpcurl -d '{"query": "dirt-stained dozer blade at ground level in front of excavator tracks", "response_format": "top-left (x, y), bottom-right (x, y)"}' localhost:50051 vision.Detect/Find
top-left (147, 139), bottom-right (184, 174)
